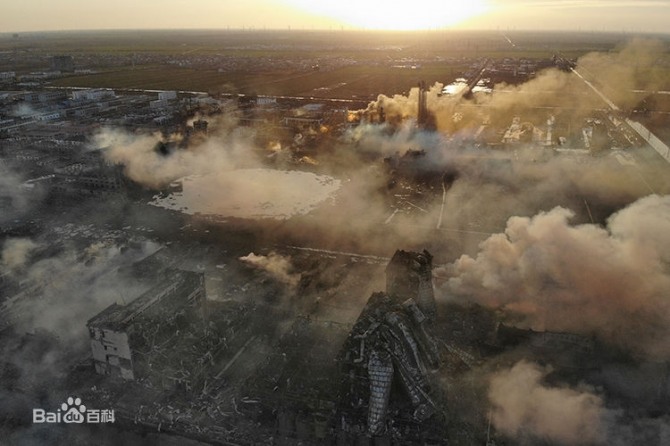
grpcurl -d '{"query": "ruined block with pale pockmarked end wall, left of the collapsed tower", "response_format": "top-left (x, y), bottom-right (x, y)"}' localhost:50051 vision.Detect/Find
top-left (87, 269), bottom-right (205, 380)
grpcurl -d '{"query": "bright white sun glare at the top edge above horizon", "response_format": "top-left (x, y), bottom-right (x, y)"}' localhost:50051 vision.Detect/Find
top-left (286, 0), bottom-right (490, 31)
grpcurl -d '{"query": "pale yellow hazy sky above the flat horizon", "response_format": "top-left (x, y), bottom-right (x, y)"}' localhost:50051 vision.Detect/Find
top-left (0, 0), bottom-right (670, 32)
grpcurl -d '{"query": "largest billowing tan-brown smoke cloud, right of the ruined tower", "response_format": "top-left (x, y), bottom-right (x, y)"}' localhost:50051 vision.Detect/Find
top-left (441, 195), bottom-right (670, 359)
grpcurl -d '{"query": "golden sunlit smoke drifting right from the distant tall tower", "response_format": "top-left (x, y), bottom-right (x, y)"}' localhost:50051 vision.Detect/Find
top-left (360, 38), bottom-right (667, 136)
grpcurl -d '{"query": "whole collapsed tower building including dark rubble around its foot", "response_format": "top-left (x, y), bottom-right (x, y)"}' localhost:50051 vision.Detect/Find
top-left (340, 250), bottom-right (444, 443)
